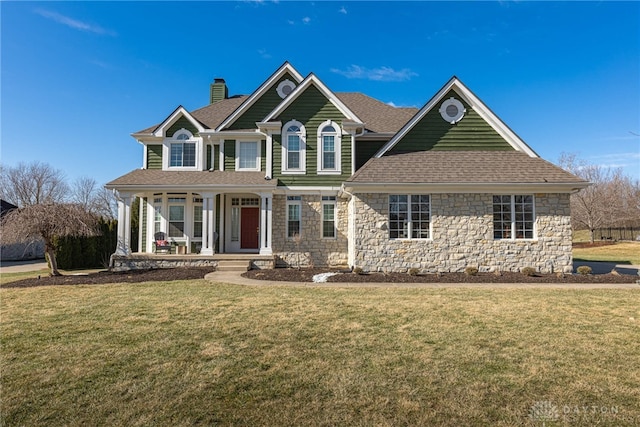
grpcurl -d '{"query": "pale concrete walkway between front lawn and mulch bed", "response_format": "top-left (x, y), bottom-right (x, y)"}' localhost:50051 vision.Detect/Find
top-left (204, 271), bottom-right (640, 291)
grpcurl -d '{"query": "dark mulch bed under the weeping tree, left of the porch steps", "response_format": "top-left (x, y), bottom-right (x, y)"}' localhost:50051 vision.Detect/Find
top-left (2, 267), bottom-right (215, 288)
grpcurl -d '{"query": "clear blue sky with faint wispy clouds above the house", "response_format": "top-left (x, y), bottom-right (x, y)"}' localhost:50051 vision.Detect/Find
top-left (0, 1), bottom-right (640, 184)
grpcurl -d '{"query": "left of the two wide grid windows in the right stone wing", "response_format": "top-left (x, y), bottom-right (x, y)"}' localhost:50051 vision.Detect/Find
top-left (389, 194), bottom-right (431, 239)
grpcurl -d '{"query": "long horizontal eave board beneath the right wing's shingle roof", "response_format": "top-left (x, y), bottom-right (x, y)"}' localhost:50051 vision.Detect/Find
top-left (344, 182), bottom-right (589, 194)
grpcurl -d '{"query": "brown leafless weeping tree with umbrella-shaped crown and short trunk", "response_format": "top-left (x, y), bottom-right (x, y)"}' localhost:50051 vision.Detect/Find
top-left (0, 203), bottom-right (98, 276)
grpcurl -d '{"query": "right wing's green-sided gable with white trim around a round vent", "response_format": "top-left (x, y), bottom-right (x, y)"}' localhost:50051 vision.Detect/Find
top-left (375, 76), bottom-right (538, 158)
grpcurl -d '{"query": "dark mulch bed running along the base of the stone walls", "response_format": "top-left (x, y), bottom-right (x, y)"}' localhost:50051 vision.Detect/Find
top-left (243, 268), bottom-right (640, 283)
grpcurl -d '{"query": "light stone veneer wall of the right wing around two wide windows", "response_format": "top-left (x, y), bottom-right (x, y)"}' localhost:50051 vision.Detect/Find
top-left (355, 194), bottom-right (573, 273)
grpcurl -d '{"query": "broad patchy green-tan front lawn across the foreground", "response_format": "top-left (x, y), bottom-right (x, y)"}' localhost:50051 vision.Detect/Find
top-left (0, 280), bottom-right (640, 426)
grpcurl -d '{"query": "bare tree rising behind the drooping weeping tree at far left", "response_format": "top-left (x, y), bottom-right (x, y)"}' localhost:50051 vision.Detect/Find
top-left (0, 162), bottom-right (68, 207)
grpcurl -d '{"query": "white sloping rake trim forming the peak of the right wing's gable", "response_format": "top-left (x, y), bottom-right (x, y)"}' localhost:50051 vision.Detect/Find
top-left (375, 76), bottom-right (538, 157)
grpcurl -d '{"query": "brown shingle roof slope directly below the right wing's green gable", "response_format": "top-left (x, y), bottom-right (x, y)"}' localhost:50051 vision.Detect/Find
top-left (347, 151), bottom-right (587, 184)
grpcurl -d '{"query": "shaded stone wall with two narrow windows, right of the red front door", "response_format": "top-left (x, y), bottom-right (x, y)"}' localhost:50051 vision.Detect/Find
top-left (272, 194), bottom-right (348, 267)
